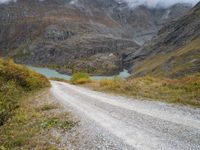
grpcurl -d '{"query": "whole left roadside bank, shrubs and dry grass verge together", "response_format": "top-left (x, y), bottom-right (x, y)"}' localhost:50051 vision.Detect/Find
top-left (0, 59), bottom-right (76, 150)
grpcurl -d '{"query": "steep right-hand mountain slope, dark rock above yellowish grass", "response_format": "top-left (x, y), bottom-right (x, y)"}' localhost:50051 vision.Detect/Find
top-left (124, 3), bottom-right (200, 77)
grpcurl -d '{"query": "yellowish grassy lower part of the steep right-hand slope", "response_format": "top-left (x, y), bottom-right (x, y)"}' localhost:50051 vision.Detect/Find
top-left (134, 38), bottom-right (200, 77)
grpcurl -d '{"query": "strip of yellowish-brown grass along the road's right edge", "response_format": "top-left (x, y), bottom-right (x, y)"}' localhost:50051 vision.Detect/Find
top-left (86, 74), bottom-right (200, 107)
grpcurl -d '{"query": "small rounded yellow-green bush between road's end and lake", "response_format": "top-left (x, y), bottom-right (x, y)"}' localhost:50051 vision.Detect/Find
top-left (70, 72), bottom-right (91, 84)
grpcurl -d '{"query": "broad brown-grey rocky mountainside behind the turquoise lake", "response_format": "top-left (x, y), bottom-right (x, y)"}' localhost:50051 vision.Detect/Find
top-left (0, 0), bottom-right (191, 74)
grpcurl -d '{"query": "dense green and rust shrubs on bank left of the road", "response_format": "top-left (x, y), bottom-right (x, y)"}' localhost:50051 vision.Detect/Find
top-left (0, 59), bottom-right (50, 125)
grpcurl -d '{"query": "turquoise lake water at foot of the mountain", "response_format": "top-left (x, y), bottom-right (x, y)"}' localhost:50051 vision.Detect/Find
top-left (28, 66), bottom-right (130, 80)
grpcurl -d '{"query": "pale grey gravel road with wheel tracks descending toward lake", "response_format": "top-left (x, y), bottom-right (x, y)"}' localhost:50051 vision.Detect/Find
top-left (51, 81), bottom-right (200, 150)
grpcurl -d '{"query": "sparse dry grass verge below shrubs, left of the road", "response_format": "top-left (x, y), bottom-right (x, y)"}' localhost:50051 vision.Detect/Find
top-left (0, 89), bottom-right (76, 150)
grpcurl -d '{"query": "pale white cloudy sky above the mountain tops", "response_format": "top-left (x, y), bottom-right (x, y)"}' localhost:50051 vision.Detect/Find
top-left (0, 0), bottom-right (200, 8)
